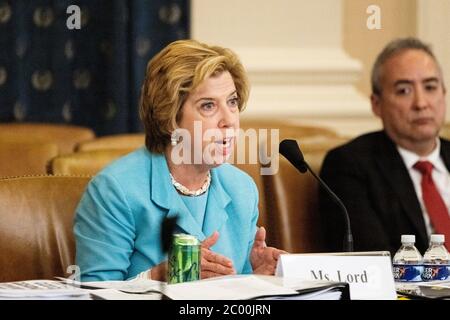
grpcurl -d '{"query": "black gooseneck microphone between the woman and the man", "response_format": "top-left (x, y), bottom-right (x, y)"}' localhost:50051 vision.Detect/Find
top-left (279, 139), bottom-right (353, 252)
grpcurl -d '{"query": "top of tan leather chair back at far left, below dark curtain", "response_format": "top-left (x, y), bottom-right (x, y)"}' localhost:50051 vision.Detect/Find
top-left (0, 123), bottom-right (95, 154)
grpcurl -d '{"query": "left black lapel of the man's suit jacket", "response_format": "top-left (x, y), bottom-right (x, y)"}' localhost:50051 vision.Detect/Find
top-left (375, 132), bottom-right (427, 243)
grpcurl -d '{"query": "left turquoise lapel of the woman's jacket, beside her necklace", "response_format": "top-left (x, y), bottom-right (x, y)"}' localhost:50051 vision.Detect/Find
top-left (150, 153), bottom-right (209, 240)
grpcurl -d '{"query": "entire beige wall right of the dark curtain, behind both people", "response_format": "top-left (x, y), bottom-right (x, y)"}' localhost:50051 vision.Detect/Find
top-left (191, 0), bottom-right (450, 135)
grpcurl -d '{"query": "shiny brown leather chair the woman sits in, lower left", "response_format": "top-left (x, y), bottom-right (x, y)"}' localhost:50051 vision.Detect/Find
top-left (0, 176), bottom-right (89, 282)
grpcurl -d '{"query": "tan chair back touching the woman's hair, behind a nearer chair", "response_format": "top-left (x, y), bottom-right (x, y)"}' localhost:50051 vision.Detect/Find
top-left (76, 133), bottom-right (145, 151)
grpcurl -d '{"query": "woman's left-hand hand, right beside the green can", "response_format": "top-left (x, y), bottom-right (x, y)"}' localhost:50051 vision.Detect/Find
top-left (200, 231), bottom-right (236, 279)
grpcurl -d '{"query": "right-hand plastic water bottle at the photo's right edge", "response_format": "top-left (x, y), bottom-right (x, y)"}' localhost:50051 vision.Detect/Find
top-left (422, 234), bottom-right (450, 281)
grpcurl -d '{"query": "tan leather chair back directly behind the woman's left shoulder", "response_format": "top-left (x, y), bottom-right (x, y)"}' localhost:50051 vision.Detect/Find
top-left (48, 149), bottom-right (133, 176)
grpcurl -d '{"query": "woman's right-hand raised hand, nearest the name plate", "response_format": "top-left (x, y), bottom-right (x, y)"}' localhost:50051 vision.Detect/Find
top-left (250, 227), bottom-right (287, 275)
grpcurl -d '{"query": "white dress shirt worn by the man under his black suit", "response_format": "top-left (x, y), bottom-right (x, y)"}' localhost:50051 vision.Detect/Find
top-left (397, 139), bottom-right (450, 236)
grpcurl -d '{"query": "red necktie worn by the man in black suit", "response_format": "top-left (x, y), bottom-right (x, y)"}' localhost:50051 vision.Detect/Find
top-left (414, 161), bottom-right (450, 249)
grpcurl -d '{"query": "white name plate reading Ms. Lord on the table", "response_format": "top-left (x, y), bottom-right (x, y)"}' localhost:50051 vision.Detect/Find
top-left (275, 253), bottom-right (397, 300)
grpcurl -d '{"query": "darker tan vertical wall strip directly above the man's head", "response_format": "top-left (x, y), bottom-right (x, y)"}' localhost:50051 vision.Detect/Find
top-left (342, 0), bottom-right (417, 96)
